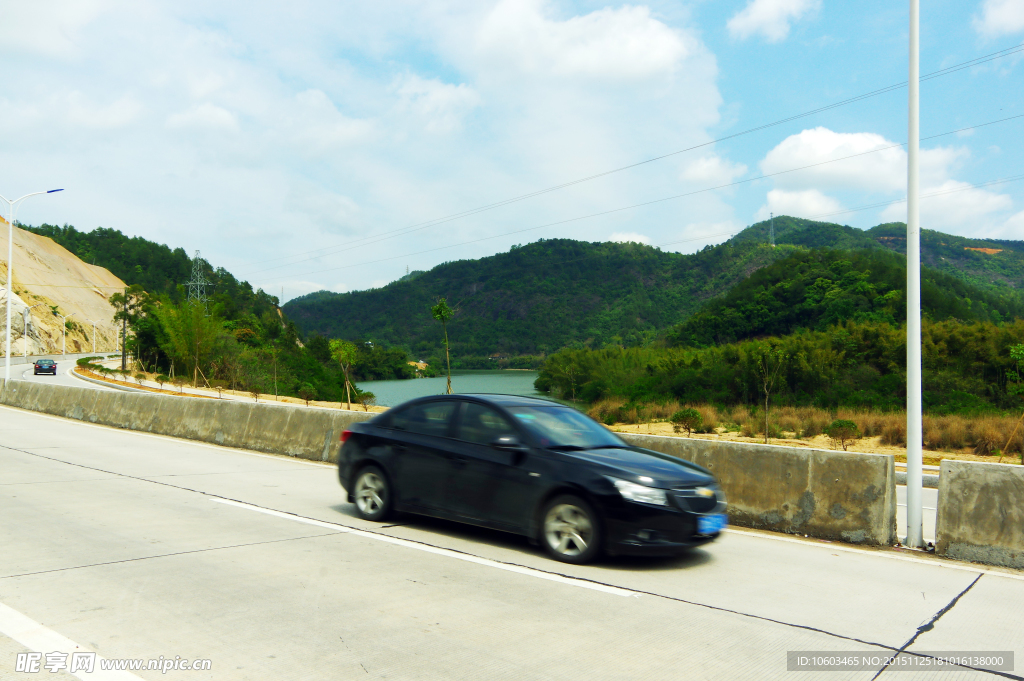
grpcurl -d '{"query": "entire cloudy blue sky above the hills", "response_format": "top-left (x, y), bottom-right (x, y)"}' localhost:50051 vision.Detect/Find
top-left (0, 0), bottom-right (1024, 299)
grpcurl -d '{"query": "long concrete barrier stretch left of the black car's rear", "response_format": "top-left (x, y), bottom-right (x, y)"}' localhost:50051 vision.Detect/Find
top-left (0, 381), bottom-right (373, 462)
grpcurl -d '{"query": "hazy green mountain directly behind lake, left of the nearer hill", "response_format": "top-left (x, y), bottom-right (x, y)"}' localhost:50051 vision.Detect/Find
top-left (284, 239), bottom-right (796, 358)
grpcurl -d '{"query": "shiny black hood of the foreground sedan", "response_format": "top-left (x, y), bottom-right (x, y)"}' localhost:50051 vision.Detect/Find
top-left (565, 448), bottom-right (715, 490)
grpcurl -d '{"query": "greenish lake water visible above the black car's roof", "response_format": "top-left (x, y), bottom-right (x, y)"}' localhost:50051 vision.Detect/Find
top-left (356, 370), bottom-right (547, 407)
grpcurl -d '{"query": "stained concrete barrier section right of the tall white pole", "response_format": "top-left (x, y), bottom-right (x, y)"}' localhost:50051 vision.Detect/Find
top-left (935, 461), bottom-right (1024, 568)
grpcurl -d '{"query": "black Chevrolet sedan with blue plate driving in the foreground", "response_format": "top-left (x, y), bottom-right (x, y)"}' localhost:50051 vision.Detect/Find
top-left (338, 394), bottom-right (726, 563)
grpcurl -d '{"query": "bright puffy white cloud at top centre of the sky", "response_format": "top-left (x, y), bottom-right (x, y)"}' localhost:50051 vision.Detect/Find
top-left (475, 0), bottom-right (689, 80)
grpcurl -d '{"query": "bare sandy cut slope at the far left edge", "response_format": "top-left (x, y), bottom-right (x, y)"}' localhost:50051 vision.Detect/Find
top-left (0, 218), bottom-right (125, 356)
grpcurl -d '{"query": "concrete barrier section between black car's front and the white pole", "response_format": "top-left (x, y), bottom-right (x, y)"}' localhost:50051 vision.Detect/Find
top-left (620, 433), bottom-right (896, 546)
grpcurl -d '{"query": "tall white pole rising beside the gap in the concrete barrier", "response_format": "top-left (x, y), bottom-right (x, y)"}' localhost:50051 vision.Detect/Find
top-left (906, 0), bottom-right (925, 548)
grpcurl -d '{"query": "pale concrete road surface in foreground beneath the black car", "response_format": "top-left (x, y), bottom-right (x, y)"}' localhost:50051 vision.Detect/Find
top-left (0, 408), bottom-right (1024, 681)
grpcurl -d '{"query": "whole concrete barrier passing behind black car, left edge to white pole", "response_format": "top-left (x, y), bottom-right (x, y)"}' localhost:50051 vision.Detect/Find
top-left (0, 381), bottom-right (896, 545)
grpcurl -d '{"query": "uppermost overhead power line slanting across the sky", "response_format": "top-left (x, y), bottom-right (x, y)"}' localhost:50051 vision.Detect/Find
top-left (245, 39), bottom-right (1024, 276)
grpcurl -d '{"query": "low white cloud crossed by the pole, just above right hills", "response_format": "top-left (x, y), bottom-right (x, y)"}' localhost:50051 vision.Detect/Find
top-left (882, 180), bottom-right (1014, 232)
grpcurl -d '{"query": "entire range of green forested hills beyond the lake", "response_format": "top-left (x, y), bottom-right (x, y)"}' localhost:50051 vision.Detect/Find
top-left (285, 216), bottom-right (1024, 366)
